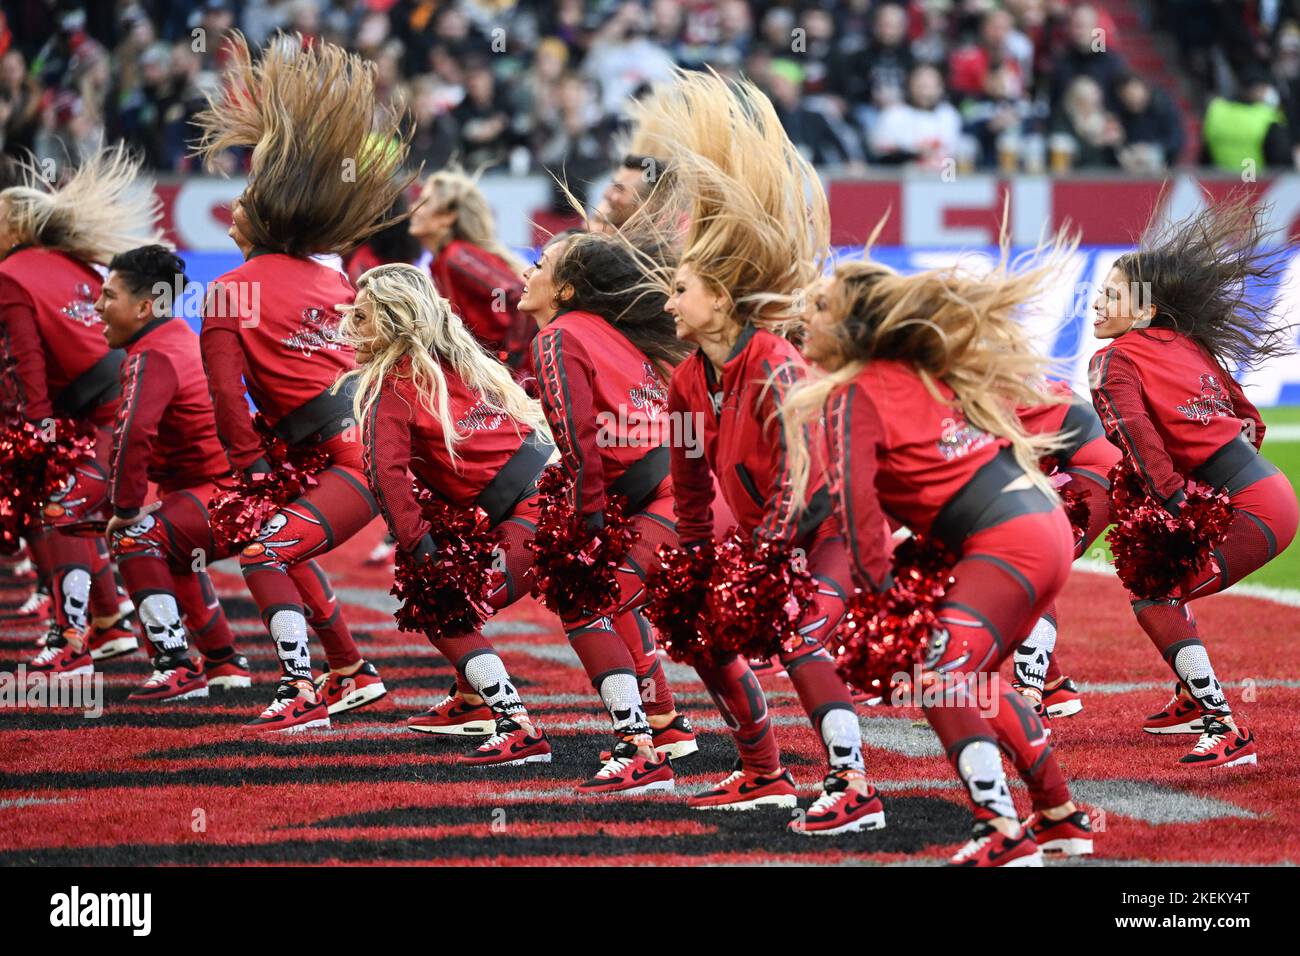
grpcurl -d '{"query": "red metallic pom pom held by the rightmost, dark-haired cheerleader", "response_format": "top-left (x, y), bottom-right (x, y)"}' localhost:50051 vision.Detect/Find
top-left (1106, 458), bottom-right (1232, 601)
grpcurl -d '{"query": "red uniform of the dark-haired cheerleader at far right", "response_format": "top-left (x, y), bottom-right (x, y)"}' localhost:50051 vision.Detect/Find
top-left (1088, 328), bottom-right (1297, 713)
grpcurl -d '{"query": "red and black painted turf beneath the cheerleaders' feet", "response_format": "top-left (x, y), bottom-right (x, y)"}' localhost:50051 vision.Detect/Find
top-left (0, 524), bottom-right (1300, 866)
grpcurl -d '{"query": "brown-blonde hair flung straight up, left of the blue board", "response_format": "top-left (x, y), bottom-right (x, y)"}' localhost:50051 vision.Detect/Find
top-left (194, 34), bottom-right (416, 256)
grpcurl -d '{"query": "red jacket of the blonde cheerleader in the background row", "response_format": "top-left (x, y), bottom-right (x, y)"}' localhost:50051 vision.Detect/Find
top-left (429, 239), bottom-right (537, 365)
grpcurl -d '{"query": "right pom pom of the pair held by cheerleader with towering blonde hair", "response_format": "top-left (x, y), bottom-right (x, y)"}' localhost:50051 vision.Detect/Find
top-left (706, 531), bottom-right (816, 658)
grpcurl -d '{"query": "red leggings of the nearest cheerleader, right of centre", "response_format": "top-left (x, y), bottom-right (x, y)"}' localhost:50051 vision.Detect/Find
top-left (924, 509), bottom-right (1074, 816)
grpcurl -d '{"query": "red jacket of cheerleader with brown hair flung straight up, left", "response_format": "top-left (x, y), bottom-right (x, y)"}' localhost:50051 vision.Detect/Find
top-left (199, 252), bottom-right (356, 468)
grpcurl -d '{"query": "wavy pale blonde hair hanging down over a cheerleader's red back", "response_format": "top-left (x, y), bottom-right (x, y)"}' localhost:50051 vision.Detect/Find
top-left (333, 263), bottom-right (550, 462)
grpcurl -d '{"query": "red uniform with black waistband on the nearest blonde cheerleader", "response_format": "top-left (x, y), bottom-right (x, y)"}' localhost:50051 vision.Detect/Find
top-left (826, 362), bottom-right (1074, 817)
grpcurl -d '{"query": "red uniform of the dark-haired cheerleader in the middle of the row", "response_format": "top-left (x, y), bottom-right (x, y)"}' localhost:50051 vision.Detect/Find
top-left (533, 312), bottom-right (677, 714)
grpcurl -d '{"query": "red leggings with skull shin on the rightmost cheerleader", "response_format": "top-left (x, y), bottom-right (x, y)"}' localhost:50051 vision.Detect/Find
top-left (1131, 473), bottom-right (1297, 714)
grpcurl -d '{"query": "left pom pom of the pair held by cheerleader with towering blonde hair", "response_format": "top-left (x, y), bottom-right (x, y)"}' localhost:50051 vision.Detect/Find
top-left (641, 545), bottom-right (715, 666)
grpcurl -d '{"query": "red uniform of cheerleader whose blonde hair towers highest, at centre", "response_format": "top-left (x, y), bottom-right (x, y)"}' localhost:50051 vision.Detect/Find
top-left (668, 325), bottom-right (879, 777)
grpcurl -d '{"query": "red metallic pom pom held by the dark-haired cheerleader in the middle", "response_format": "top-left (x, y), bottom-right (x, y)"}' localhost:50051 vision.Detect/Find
top-left (528, 464), bottom-right (641, 620)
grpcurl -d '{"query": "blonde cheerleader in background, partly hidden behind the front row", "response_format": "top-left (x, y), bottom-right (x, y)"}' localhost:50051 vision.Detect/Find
top-left (410, 169), bottom-right (537, 368)
